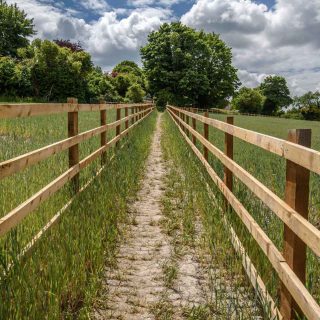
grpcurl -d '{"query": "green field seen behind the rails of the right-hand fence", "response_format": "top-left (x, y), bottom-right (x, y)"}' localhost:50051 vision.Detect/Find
top-left (178, 110), bottom-right (320, 312)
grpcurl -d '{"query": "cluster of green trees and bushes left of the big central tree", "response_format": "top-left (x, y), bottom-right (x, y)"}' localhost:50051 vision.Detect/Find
top-left (0, 0), bottom-right (147, 102)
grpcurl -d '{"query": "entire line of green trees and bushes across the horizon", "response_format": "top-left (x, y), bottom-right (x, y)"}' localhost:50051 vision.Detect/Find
top-left (0, 0), bottom-right (320, 120)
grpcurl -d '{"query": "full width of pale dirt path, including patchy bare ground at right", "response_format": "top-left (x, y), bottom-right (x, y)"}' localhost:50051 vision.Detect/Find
top-left (92, 114), bottom-right (260, 320)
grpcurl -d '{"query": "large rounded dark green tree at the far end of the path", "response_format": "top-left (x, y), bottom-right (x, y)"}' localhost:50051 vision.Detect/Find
top-left (141, 22), bottom-right (239, 107)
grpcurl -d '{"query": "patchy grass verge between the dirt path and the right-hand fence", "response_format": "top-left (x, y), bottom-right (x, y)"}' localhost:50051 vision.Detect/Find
top-left (159, 114), bottom-right (263, 319)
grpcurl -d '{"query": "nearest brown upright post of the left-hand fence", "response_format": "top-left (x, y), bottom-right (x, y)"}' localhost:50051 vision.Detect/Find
top-left (67, 98), bottom-right (80, 193)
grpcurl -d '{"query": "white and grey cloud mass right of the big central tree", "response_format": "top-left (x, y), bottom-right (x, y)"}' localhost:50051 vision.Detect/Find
top-left (181, 0), bottom-right (320, 94)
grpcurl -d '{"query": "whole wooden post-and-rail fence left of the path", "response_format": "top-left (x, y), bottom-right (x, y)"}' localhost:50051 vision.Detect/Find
top-left (0, 98), bottom-right (154, 264)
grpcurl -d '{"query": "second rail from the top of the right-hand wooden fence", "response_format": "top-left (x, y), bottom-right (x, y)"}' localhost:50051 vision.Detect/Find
top-left (169, 109), bottom-right (320, 256)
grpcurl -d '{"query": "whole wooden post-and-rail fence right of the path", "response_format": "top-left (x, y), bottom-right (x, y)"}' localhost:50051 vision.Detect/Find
top-left (167, 106), bottom-right (320, 320)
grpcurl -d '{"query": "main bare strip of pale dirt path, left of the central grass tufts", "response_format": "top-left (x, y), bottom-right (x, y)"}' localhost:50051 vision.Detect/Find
top-left (95, 115), bottom-right (170, 320)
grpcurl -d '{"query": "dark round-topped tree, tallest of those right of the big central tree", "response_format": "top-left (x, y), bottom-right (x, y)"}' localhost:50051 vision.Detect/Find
top-left (260, 76), bottom-right (292, 115)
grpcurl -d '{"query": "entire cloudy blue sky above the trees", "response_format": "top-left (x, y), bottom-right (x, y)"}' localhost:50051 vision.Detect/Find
top-left (7, 0), bottom-right (320, 95)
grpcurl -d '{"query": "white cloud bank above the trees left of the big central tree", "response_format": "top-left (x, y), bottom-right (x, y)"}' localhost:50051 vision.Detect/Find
top-left (8, 0), bottom-right (172, 70)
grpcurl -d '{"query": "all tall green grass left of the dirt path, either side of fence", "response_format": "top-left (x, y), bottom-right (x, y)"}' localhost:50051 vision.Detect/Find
top-left (0, 112), bottom-right (155, 319)
